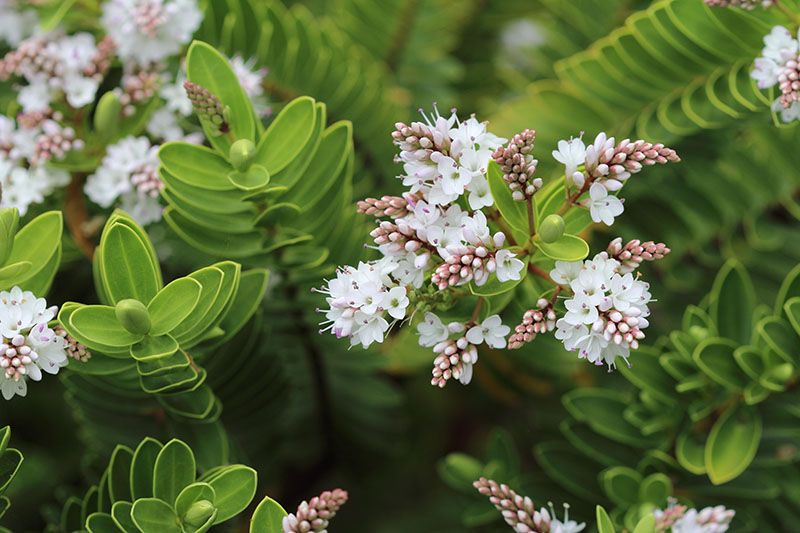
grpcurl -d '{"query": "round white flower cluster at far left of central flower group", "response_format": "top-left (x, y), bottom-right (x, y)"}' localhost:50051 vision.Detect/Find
top-left (319, 260), bottom-right (409, 348)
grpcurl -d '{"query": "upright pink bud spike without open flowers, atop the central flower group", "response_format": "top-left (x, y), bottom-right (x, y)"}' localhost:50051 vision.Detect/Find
top-left (492, 129), bottom-right (542, 202)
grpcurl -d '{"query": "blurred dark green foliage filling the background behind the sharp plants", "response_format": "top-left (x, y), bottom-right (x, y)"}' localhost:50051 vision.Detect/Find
top-left (0, 0), bottom-right (800, 533)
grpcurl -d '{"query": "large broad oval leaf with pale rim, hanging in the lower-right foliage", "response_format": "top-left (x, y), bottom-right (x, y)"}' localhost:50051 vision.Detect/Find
top-left (705, 405), bottom-right (761, 485)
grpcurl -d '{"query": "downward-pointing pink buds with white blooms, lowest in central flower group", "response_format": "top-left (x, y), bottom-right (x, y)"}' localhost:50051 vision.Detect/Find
top-left (417, 313), bottom-right (511, 387)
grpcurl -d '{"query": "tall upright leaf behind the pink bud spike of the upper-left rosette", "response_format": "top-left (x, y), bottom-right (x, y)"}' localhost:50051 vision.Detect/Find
top-left (186, 41), bottom-right (256, 150)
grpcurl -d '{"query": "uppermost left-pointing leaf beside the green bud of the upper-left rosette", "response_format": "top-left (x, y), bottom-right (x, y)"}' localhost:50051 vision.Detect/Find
top-left (158, 142), bottom-right (241, 191)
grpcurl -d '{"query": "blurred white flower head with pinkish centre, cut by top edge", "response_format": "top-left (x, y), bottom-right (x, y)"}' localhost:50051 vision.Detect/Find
top-left (101, 0), bottom-right (203, 65)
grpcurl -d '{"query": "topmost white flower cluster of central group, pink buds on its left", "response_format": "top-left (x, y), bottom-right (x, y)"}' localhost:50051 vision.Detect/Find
top-left (400, 107), bottom-right (506, 209)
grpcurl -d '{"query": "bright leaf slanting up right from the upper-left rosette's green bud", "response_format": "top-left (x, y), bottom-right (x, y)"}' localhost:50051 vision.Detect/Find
top-left (254, 96), bottom-right (317, 176)
